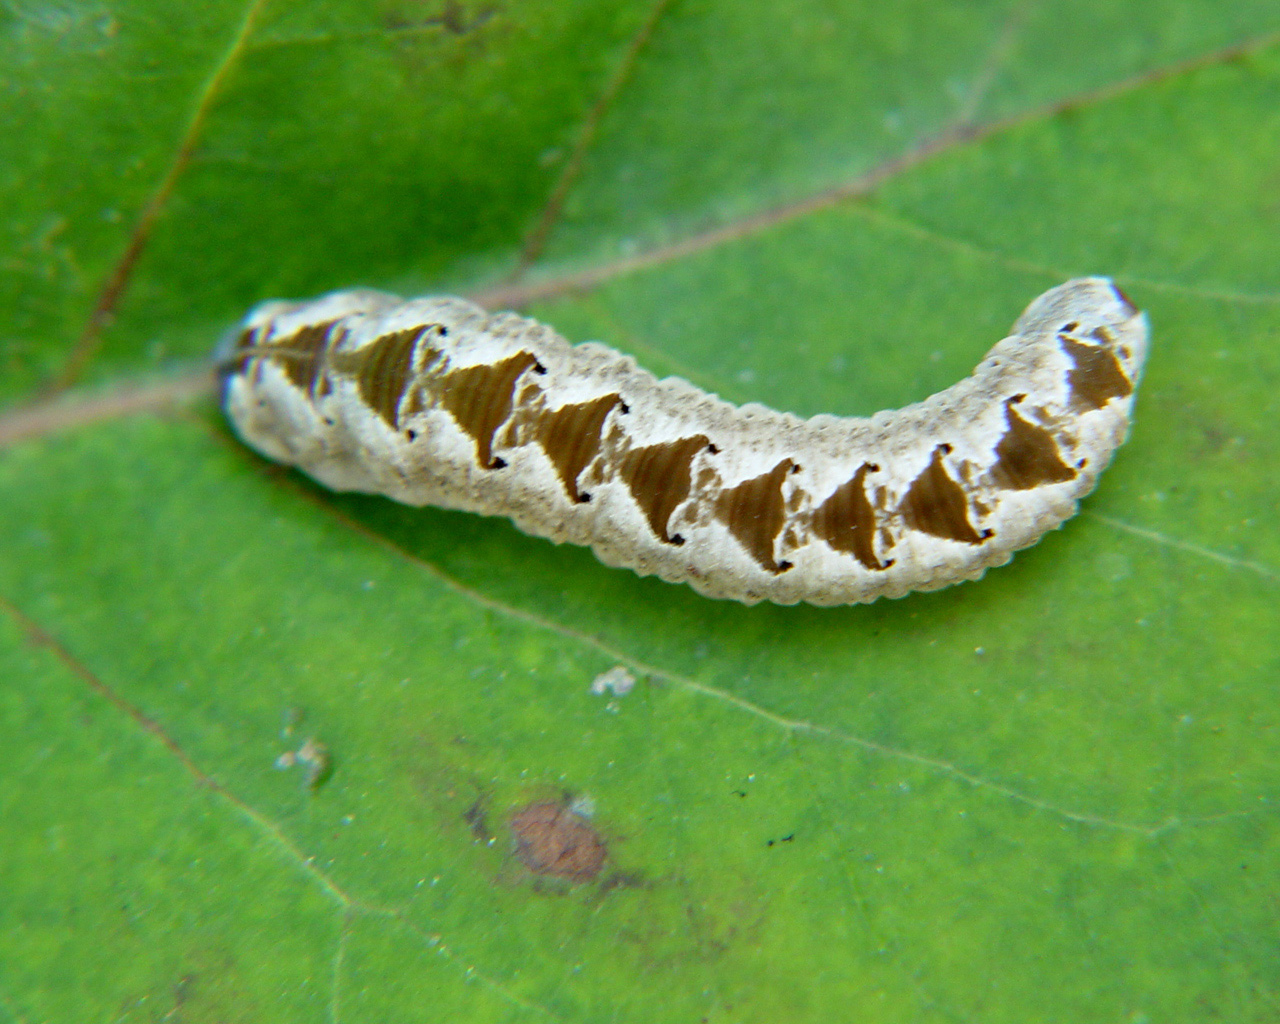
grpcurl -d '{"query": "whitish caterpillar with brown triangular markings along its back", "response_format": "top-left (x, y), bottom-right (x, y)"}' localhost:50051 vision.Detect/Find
top-left (225, 278), bottom-right (1147, 604)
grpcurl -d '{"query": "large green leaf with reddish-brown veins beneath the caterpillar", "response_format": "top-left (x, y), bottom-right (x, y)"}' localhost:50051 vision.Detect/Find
top-left (0, 0), bottom-right (1280, 1024)
